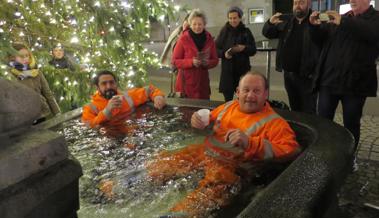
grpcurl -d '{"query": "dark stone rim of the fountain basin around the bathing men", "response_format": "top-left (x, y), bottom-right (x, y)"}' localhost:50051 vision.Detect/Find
top-left (39, 98), bottom-right (354, 218)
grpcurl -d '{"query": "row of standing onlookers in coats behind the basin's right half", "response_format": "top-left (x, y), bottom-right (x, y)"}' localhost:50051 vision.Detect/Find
top-left (162, 0), bottom-right (379, 148)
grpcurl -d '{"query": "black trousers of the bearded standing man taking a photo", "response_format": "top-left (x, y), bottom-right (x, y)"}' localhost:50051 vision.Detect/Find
top-left (284, 71), bottom-right (317, 114)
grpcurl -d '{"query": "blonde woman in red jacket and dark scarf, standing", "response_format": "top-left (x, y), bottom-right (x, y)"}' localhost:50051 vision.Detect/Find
top-left (172, 9), bottom-right (218, 99)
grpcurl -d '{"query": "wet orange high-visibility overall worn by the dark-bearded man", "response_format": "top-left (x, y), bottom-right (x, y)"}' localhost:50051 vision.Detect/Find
top-left (82, 85), bottom-right (164, 135)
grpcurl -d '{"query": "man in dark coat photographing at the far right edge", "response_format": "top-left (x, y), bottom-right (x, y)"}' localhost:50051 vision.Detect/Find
top-left (310, 0), bottom-right (379, 146)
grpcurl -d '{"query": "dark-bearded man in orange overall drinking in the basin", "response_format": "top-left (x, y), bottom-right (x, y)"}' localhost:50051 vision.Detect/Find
top-left (82, 71), bottom-right (166, 136)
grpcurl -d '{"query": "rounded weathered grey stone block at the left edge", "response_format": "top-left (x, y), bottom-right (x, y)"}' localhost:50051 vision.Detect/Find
top-left (0, 130), bottom-right (68, 192)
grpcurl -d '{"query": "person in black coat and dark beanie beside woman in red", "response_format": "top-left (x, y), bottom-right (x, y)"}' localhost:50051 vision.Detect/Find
top-left (216, 7), bottom-right (257, 101)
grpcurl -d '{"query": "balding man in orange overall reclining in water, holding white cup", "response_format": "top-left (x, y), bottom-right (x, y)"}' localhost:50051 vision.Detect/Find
top-left (147, 72), bottom-right (300, 217)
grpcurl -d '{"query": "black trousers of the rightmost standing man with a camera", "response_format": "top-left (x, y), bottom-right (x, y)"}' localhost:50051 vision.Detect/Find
top-left (317, 88), bottom-right (366, 148)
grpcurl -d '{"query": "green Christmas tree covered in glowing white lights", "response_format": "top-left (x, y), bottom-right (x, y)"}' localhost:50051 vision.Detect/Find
top-left (0, 0), bottom-right (184, 111)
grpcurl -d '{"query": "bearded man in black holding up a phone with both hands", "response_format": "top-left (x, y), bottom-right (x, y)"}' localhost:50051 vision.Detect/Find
top-left (262, 0), bottom-right (321, 113)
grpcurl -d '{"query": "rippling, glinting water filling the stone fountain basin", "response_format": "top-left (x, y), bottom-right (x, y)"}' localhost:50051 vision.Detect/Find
top-left (60, 106), bottom-right (209, 217)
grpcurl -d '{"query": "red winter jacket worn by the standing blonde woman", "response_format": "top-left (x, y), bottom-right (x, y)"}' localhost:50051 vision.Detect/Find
top-left (171, 30), bottom-right (218, 99)
